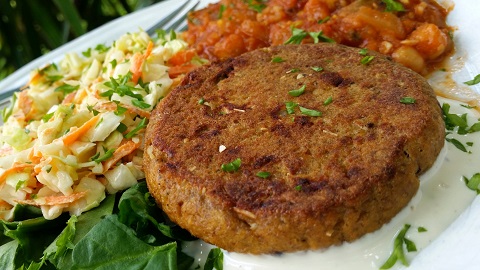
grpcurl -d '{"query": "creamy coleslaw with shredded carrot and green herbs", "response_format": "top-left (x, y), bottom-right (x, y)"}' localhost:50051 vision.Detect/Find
top-left (0, 30), bottom-right (204, 220)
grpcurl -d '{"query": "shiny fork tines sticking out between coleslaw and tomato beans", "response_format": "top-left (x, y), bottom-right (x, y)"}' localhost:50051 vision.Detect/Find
top-left (146, 0), bottom-right (200, 36)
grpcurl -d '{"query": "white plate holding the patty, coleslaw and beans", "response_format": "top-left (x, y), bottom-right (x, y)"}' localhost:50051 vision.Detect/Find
top-left (0, 0), bottom-right (480, 270)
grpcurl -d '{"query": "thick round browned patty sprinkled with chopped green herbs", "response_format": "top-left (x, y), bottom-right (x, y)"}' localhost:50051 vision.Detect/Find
top-left (144, 44), bottom-right (445, 254)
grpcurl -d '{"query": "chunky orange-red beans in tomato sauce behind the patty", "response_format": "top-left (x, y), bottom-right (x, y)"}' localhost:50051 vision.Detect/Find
top-left (183, 0), bottom-right (453, 75)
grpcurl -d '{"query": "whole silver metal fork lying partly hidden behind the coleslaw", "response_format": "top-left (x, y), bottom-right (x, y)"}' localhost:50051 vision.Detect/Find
top-left (0, 0), bottom-right (200, 109)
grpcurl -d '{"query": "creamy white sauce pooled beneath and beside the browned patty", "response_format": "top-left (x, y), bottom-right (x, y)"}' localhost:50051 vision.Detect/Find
top-left (186, 97), bottom-right (480, 270)
